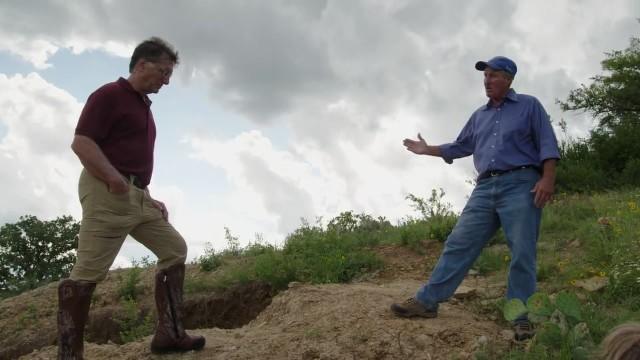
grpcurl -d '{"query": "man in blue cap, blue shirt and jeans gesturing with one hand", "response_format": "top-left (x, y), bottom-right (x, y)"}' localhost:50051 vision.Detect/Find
top-left (391, 56), bottom-right (560, 340)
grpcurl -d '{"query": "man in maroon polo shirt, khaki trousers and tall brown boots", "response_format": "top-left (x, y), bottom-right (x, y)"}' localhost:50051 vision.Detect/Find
top-left (58, 37), bottom-right (205, 359)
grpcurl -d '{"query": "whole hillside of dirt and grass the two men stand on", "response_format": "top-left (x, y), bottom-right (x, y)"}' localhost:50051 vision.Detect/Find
top-left (0, 189), bottom-right (640, 359)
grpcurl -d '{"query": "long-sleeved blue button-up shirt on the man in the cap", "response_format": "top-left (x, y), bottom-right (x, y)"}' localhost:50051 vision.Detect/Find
top-left (440, 89), bottom-right (560, 174)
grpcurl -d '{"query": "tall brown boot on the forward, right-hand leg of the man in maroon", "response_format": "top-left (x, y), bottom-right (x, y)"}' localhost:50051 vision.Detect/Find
top-left (151, 264), bottom-right (205, 353)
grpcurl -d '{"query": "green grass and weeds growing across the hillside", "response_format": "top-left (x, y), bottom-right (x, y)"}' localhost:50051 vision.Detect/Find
top-left (185, 189), bottom-right (640, 359)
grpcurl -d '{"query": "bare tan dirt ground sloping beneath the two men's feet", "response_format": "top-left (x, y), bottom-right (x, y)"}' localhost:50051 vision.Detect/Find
top-left (21, 243), bottom-right (509, 360)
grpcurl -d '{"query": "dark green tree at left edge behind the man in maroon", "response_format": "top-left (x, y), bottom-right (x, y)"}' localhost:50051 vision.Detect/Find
top-left (0, 215), bottom-right (80, 293)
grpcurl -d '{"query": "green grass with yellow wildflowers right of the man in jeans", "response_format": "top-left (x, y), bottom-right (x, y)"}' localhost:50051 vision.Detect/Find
top-left (503, 189), bottom-right (640, 359)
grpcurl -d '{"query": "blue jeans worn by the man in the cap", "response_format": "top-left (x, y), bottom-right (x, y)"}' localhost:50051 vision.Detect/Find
top-left (416, 169), bottom-right (542, 309)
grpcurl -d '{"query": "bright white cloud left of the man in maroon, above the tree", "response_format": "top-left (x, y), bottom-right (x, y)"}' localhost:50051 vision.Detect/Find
top-left (0, 73), bottom-right (81, 221)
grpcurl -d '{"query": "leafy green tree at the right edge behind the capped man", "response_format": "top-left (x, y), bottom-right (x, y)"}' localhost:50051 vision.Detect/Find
top-left (557, 33), bottom-right (640, 191)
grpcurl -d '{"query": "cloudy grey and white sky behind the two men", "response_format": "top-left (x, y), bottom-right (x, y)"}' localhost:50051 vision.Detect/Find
top-left (0, 0), bottom-right (640, 264)
